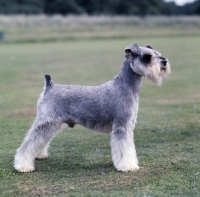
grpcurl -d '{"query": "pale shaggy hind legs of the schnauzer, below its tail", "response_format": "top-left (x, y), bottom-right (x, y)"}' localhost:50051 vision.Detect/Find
top-left (14, 119), bottom-right (62, 172)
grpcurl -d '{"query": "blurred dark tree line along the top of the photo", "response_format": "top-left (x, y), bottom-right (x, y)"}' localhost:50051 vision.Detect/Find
top-left (0, 0), bottom-right (200, 16)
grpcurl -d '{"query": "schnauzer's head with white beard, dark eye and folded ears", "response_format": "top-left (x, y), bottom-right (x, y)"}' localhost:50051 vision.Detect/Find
top-left (125, 43), bottom-right (171, 86)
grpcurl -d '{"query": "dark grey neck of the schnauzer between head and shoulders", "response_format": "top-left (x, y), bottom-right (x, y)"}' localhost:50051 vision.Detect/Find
top-left (114, 60), bottom-right (142, 94)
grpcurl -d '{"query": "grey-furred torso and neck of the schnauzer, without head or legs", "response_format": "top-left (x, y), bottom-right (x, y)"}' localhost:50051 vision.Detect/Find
top-left (41, 61), bottom-right (142, 133)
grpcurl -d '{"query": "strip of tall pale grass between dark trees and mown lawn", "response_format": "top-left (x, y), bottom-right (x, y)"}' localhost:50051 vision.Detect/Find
top-left (0, 15), bottom-right (200, 42)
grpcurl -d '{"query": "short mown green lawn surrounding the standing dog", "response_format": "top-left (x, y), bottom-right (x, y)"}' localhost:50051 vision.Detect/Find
top-left (0, 16), bottom-right (200, 197)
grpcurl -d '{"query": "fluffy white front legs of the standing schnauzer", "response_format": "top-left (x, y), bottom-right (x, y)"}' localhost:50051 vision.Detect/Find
top-left (111, 124), bottom-right (139, 172)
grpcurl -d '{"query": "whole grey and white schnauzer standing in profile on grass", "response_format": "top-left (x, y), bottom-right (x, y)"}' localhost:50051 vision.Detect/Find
top-left (14, 43), bottom-right (170, 172)
